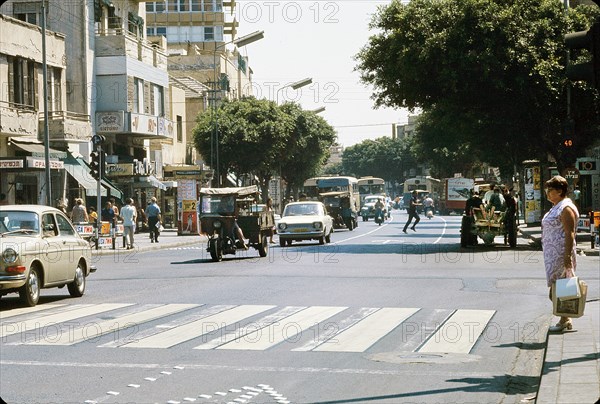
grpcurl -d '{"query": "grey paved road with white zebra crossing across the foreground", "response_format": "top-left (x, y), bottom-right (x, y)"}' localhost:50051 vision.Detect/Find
top-left (0, 215), bottom-right (598, 403)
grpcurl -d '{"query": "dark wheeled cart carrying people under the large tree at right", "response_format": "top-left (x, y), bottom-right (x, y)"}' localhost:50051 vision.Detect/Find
top-left (460, 208), bottom-right (517, 248)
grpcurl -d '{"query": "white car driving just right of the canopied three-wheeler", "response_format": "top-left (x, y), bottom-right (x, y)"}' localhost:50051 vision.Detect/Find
top-left (277, 201), bottom-right (333, 247)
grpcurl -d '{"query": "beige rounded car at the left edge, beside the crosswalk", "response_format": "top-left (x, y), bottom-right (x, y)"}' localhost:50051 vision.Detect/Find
top-left (0, 205), bottom-right (96, 306)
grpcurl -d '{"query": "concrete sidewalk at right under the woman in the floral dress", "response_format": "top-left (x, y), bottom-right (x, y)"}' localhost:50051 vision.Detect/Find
top-left (519, 226), bottom-right (600, 404)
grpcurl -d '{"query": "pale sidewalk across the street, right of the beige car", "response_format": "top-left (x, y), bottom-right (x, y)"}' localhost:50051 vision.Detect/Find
top-left (92, 229), bottom-right (206, 255)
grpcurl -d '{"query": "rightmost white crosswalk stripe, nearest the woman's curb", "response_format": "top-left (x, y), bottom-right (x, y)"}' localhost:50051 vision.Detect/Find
top-left (418, 310), bottom-right (496, 354)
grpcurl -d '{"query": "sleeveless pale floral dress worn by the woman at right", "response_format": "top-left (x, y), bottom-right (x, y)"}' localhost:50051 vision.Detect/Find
top-left (542, 198), bottom-right (579, 286)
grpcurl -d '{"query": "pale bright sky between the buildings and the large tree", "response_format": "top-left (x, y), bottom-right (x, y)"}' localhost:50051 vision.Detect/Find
top-left (230, 0), bottom-right (408, 147)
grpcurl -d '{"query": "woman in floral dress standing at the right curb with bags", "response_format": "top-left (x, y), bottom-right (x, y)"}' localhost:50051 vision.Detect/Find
top-left (542, 175), bottom-right (579, 332)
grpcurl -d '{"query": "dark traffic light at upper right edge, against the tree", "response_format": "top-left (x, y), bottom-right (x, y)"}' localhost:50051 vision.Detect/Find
top-left (565, 20), bottom-right (600, 90)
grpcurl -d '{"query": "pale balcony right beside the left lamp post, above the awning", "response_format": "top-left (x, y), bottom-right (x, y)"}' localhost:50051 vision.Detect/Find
top-left (39, 111), bottom-right (92, 142)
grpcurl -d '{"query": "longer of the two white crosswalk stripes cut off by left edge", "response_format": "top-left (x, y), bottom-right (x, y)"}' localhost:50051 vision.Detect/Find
top-left (0, 303), bottom-right (133, 337)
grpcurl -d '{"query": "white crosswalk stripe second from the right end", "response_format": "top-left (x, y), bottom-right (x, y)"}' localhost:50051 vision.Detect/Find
top-left (314, 308), bottom-right (419, 352)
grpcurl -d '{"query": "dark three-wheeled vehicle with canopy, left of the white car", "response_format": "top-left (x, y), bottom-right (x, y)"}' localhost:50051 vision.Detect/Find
top-left (198, 185), bottom-right (275, 262)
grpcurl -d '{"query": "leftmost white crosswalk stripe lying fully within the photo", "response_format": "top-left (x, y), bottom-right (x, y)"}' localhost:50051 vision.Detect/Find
top-left (26, 304), bottom-right (198, 345)
